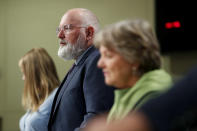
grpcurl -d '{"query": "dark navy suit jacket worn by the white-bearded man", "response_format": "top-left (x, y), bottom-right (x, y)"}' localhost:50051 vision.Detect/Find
top-left (48, 46), bottom-right (114, 131)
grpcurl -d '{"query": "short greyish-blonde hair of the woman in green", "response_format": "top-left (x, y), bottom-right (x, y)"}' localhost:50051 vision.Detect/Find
top-left (94, 19), bottom-right (161, 74)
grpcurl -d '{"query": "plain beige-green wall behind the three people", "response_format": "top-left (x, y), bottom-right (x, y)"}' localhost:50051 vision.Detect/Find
top-left (0, 0), bottom-right (196, 131)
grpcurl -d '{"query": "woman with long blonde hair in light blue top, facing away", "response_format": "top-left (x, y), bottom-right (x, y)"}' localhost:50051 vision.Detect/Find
top-left (19, 48), bottom-right (60, 131)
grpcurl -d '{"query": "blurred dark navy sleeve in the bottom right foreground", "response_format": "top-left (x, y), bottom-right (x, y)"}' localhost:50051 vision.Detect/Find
top-left (140, 67), bottom-right (197, 131)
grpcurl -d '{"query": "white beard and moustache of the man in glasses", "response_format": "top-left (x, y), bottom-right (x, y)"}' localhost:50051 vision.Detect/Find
top-left (58, 35), bottom-right (86, 60)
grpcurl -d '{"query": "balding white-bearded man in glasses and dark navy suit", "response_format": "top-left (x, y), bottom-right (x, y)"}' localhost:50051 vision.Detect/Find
top-left (48, 8), bottom-right (114, 131)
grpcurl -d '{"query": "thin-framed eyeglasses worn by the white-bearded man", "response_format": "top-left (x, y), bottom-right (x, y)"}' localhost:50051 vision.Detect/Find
top-left (56, 24), bottom-right (87, 35)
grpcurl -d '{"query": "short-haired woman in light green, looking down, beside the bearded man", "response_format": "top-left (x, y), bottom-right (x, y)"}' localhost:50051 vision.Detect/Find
top-left (94, 19), bottom-right (172, 121)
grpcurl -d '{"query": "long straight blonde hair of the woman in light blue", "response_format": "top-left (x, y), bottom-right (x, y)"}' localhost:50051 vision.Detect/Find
top-left (19, 48), bottom-right (60, 111)
